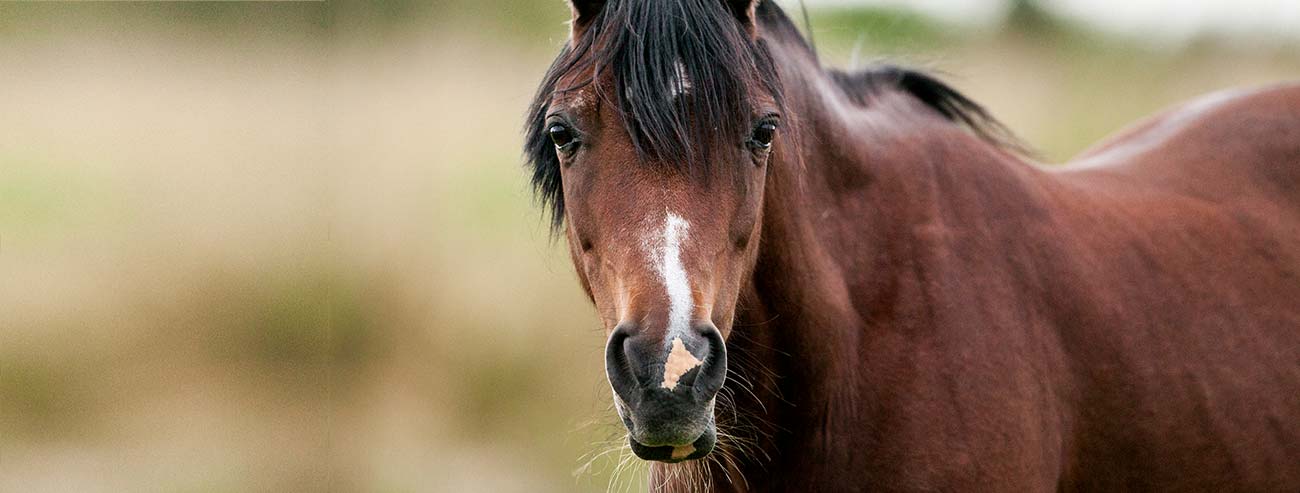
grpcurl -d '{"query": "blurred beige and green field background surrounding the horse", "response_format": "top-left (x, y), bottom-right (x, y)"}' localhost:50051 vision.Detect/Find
top-left (0, 0), bottom-right (1300, 492)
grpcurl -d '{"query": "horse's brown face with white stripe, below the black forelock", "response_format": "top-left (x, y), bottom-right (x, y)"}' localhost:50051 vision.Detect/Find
top-left (546, 76), bottom-right (779, 462)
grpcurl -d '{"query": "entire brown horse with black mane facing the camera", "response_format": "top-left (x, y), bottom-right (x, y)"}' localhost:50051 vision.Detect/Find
top-left (527, 0), bottom-right (1300, 492)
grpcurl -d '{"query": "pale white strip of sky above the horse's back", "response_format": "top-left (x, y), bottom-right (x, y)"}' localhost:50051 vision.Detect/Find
top-left (783, 0), bottom-right (1300, 44)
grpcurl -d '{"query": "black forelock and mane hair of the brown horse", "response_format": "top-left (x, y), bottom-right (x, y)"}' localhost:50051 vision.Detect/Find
top-left (524, 0), bottom-right (1019, 228)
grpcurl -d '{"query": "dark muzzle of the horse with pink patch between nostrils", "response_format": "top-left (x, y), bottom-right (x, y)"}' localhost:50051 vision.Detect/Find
top-left (605, 323), bottom-right (727, 462)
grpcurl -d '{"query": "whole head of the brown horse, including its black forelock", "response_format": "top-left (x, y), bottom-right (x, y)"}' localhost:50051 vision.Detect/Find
top-left (525, 0), bottom-right (780, 462)
